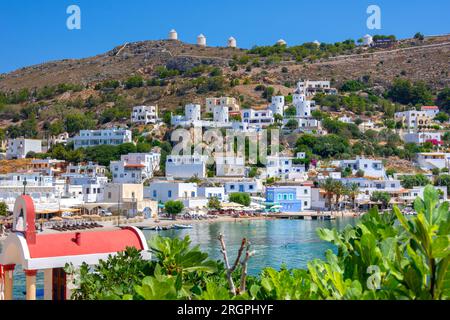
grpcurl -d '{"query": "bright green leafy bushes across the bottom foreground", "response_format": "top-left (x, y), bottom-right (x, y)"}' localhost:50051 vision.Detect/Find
top-left (68, 186), bottom-right (450, 300)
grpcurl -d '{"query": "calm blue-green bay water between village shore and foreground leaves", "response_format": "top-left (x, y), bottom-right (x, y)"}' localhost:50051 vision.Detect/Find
top-left (0, 218), bottom-right (356, 299)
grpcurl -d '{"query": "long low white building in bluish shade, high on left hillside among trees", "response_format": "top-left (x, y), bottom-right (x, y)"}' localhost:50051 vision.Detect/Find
top-left (71, 129), bottom-right (133, 150)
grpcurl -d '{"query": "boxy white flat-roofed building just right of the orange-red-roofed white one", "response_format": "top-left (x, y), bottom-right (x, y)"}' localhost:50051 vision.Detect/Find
top-left (166, 154), bottom-right (208, 179)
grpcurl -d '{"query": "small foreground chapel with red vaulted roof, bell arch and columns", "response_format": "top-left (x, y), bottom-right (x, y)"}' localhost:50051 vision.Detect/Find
top-left (0, 195), bottom-right (150, 300)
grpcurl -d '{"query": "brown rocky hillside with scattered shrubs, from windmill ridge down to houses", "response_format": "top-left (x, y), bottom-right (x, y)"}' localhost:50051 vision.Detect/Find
top-left (0, 35), bottom-right (450, 130)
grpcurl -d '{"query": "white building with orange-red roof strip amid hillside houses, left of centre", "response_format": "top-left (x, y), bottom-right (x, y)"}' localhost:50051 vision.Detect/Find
top-left (110, 152), bottom-right (161, 183)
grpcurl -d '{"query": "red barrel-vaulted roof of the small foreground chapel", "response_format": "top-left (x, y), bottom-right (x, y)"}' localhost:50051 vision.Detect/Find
top-left (28, 229), bottom-right (144, 258)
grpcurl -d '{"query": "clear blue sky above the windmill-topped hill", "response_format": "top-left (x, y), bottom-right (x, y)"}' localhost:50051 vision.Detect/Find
top-left (0, 0), bottom-right (450, 73)
